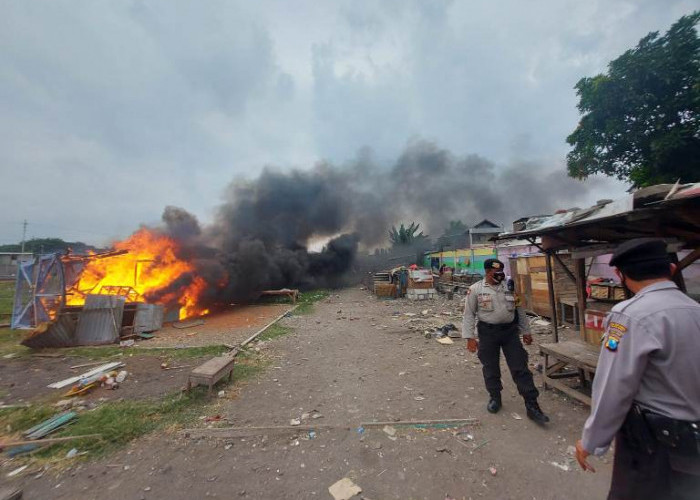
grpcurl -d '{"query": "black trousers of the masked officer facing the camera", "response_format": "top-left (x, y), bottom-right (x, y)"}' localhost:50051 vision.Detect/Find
top-left (477, 323), bottom-right (540, 401)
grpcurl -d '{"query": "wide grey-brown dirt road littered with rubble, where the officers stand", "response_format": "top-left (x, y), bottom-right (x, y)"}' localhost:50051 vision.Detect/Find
top-left (3, 289), bottom-right (611, 500)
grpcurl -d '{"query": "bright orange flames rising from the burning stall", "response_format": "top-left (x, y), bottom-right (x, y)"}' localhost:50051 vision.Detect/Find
top-left (66, 228), bottom-right (209, 319)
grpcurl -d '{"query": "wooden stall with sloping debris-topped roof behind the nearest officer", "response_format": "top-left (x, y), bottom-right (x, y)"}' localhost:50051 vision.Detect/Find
top-left (498, 184), bottom-right (700, 404)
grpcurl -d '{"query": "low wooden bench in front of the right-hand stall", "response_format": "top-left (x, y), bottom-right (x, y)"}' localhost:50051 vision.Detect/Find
top-left (540, 340), bottom-right (600, 406)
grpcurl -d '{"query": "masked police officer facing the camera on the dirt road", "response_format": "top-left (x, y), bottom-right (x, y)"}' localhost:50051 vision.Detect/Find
top-left (462, 259), bottom-right (549, 424)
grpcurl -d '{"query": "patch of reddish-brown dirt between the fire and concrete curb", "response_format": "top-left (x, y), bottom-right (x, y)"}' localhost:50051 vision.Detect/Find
top-left (141, 304), bottom-right (292, 347)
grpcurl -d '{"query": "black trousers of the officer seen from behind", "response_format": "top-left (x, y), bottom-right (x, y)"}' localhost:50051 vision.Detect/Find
top-left (608, 432), bottom-right (700, 500)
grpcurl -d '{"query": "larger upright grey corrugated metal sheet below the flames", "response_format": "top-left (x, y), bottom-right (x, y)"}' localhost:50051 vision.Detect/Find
top-left (75, 295), bottom-right (126, 345)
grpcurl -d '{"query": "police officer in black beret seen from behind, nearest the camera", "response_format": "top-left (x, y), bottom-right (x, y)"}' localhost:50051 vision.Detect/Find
top-left (576, 238), bottom-right (700, 500)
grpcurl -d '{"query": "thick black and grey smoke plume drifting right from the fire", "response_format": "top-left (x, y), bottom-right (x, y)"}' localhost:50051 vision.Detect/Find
top-left (150, 141), bottom-right (591, 303)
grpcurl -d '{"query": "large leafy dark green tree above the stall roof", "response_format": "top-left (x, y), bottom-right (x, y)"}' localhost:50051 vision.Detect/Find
top-left (567, 11), bottom-right (700, 187)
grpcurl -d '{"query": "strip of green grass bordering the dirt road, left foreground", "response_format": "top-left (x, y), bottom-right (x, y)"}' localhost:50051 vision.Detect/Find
top-left (0, 351), bottom-right (267, 462)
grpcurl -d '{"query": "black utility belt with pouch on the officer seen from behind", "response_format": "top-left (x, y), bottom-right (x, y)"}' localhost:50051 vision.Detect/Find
top-left (621, 403), bottom-right (700, 458)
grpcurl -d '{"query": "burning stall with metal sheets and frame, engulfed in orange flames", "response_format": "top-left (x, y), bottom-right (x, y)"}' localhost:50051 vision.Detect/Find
top-left (12, 228), bottom-right (208, 347)
